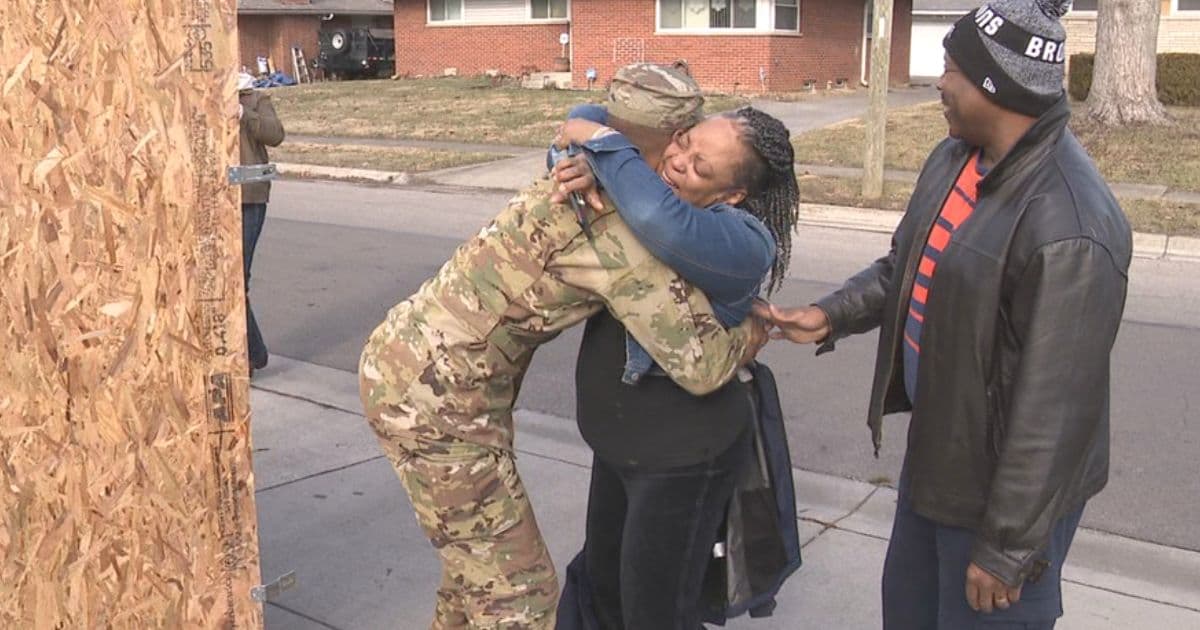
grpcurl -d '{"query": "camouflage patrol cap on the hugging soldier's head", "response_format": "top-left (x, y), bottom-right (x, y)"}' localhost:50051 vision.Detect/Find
top-left (607, 64), bottom-right (704, 130)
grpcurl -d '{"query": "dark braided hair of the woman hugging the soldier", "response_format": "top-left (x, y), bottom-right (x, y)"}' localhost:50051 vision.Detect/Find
top-left (726, 107), bottom-right (800, 294)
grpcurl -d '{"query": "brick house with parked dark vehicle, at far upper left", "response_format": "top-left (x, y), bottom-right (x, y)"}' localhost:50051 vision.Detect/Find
top-left (238, 0), bottom-right (392, 77)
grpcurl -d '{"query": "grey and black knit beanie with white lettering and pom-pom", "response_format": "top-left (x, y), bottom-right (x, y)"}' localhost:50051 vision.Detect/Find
top-left (942, 0), bottom-right (1070, 116)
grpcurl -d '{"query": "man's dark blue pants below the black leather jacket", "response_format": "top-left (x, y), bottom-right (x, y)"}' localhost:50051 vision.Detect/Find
top-left (883, 475), bottom-right (1084, 630)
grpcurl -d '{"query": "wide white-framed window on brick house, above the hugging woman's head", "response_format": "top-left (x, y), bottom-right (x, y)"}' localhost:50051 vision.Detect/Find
top-left (659, 0), bottom-right (799, 31)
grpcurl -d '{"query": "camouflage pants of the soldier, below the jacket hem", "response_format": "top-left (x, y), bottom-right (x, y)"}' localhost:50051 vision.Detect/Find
top-left (371, 419), bottom-right (558, 630)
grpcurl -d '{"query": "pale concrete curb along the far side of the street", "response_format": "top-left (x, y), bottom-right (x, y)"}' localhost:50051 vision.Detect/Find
top-left (276, 164), bottom-right (1200, 263)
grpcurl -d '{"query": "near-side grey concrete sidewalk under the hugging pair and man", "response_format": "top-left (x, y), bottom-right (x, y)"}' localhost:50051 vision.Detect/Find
top-left (251, 356), bottom-right (1200, 630)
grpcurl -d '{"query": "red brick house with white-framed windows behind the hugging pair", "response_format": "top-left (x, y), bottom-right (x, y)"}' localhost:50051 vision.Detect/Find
top-left (395, 0), bottom-right (912, 92)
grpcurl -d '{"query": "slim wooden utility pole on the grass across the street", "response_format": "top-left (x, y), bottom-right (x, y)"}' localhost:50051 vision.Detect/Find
top-left (863, 0), bottom-right (893, 199)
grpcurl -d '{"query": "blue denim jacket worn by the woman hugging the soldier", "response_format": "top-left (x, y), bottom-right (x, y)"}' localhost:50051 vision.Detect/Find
top-left (546, 104), bottom-right (775, 384)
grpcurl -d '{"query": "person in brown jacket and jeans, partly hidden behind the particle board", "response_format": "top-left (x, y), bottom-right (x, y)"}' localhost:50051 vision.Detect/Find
top-left (238, 73), bottom-right (283, 372)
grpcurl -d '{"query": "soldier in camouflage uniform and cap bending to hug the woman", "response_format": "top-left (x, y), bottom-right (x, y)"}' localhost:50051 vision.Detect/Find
top-left (359, 66), bottom-right (764, 629)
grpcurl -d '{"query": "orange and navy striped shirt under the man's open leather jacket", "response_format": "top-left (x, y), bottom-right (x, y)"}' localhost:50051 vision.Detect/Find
top-left (904, 151), bottom-right (985, 401)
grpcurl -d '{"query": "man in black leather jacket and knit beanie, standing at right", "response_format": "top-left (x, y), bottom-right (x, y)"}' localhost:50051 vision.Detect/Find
top-left (755, 0), bottom-right (1133, 630)
